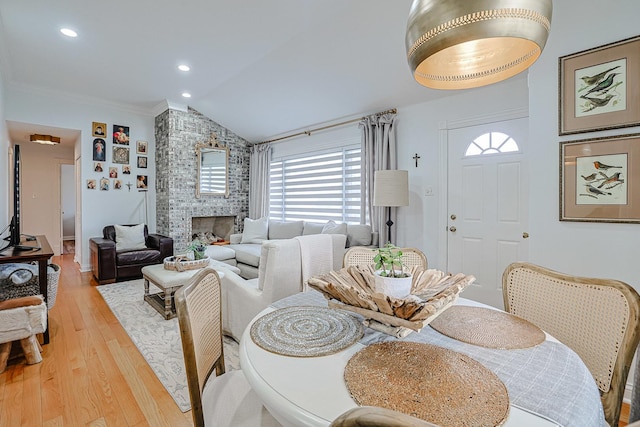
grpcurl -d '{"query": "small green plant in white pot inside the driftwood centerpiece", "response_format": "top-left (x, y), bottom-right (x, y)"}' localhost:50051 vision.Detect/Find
top-left (373, 243), bottom-right (412, 298)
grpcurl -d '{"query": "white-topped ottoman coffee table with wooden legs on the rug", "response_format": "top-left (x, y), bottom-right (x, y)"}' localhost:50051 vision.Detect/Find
top-left (142, 263), bottom-right (224, 320)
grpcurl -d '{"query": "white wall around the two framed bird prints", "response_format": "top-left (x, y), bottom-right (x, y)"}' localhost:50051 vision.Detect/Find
top-left (529, 0), bottom-right (640, 290)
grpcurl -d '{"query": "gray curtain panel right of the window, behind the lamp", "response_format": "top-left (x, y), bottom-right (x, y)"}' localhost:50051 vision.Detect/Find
top-left (359, 113), bottom-right (398, 246)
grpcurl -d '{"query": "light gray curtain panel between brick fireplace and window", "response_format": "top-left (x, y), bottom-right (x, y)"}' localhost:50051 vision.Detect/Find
top-left (249, 144), bottom-right (271, 219)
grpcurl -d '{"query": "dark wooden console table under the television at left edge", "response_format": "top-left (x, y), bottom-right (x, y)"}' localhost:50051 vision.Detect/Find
top-left (0, 235), bottom-right (53, 344)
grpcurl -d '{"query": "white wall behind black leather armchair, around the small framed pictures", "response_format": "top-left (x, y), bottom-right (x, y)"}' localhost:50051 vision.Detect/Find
top-left (5, 86), bottom-right (156, 271)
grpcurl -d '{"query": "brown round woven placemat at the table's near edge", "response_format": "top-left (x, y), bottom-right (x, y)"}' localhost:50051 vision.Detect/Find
top-left (344, 341), bottom-right (509, 427)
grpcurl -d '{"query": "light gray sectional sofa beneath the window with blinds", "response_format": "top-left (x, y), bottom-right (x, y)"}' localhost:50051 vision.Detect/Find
top-left (224, 218), bottom-right (378, 279)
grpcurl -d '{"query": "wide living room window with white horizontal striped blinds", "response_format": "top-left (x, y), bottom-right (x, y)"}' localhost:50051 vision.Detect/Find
top-left (269, 144), bottom-right (361, 224)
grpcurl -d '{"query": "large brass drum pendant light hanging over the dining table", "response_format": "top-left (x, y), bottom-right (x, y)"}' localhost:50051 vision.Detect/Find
top-left (405, 0), bottom-right (553, 89)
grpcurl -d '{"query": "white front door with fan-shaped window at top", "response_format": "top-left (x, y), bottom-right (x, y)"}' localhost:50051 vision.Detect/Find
top-left (447, 118), bottom-right (529, 308)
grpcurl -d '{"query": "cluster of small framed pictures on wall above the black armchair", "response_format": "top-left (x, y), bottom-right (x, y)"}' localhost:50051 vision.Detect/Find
top-left (87, 122), bottom-right (149, 191)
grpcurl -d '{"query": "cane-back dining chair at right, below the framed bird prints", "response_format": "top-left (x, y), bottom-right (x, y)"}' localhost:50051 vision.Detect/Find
top-left (502, 262), bottom-right (640, 427)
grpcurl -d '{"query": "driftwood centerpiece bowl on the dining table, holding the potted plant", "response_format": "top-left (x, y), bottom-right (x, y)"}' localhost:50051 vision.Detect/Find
top-left (308, 266), bottom-right (475, 338)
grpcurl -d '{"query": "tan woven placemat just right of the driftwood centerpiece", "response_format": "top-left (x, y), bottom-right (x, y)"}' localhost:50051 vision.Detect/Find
top-left (429, 305), bottom-right (545, 350)
